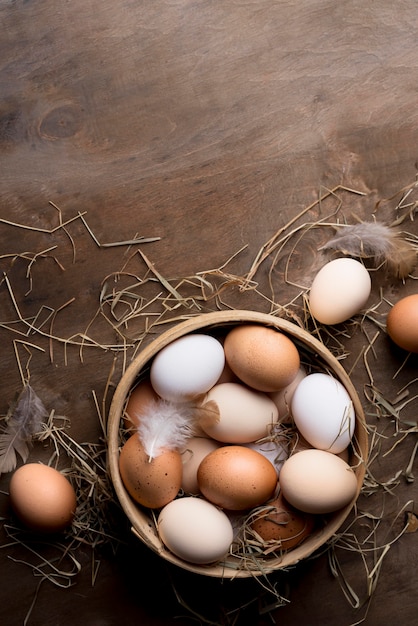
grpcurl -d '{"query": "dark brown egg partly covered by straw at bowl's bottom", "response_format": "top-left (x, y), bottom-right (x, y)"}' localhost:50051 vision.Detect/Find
top-left (251, 494), bottom-right (315, 550)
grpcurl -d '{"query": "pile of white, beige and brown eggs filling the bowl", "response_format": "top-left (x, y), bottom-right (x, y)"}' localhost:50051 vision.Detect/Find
top-left (118, 323), bottom-right (358, 565)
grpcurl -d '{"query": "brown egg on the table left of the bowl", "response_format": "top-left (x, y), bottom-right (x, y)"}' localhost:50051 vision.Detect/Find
top-left (9, 463), bottom-right (77, 533)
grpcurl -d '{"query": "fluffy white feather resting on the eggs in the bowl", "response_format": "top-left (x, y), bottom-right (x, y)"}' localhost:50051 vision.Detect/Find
top-left (138, 399), bottom-right (195, 460)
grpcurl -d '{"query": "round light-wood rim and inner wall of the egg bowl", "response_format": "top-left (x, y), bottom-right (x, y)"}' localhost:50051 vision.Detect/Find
top-left (108, 310), bottom-right (368, 578)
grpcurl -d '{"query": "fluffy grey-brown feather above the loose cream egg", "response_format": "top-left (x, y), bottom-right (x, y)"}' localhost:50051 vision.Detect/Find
top-left (320, 222), bottom-right (417, 279)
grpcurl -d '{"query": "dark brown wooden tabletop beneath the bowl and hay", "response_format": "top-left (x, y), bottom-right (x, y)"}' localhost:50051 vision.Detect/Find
top-left (0, 0), bottom-right (418, 626)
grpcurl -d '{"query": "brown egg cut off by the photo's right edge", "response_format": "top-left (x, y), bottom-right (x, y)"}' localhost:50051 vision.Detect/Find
top-left (386, 294), bottom-right (418, 353)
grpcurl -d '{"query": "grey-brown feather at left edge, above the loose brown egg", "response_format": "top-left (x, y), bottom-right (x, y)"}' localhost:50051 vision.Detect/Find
top-left (0, 384), bottom-right (48, 474)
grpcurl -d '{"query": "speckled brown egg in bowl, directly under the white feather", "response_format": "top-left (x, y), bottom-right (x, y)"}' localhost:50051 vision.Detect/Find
top-left (119, 434), bottom-right (182, 509)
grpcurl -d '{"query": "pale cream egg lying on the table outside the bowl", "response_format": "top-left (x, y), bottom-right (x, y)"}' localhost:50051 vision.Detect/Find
top-left (309, 257), bottom-right (371, 324)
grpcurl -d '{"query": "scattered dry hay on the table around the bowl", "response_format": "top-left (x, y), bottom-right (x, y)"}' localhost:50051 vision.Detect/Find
top-left (0, 182), bottom-right (418, 624)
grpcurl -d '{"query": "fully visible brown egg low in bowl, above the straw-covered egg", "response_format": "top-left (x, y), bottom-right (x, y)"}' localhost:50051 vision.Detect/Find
top-left (197, 445), bottom-right (277, 511)
